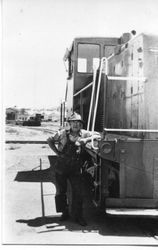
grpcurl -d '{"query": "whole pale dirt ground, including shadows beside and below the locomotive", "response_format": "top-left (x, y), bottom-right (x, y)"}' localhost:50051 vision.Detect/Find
top-left (2, 125), bottom-right (158, 246)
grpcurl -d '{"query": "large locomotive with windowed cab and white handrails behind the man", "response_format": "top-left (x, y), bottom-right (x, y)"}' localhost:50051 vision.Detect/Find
top-left (61, 33), bottom-right (158, 210)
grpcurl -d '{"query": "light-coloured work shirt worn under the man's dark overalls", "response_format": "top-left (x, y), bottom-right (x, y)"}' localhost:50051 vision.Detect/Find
top-left (52, 129), bottom-right (99, 152)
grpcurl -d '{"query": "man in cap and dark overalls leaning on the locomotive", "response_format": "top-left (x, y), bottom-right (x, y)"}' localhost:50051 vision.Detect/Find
top-left (47, 113), bottom-right (100, 226)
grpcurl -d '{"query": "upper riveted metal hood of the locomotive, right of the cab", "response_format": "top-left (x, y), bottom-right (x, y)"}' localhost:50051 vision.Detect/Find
top-left (107, 34), bottom-right (158, 139)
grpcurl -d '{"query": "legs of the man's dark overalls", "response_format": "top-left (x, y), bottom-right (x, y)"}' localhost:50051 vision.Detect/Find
top-left (56, 171), bottom-right (83, 218)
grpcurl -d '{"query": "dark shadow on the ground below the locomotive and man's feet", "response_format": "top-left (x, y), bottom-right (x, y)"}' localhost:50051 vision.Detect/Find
top-left (16, 208), bottom-right (158, 238)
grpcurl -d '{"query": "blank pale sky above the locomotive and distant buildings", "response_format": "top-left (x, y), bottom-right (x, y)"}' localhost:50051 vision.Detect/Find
top-left (1, 0), bottom-right (158, 108)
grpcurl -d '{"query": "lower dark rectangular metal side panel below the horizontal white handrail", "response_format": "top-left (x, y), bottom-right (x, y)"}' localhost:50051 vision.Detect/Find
top-left (117, 140), bottom-right (158, 199)
